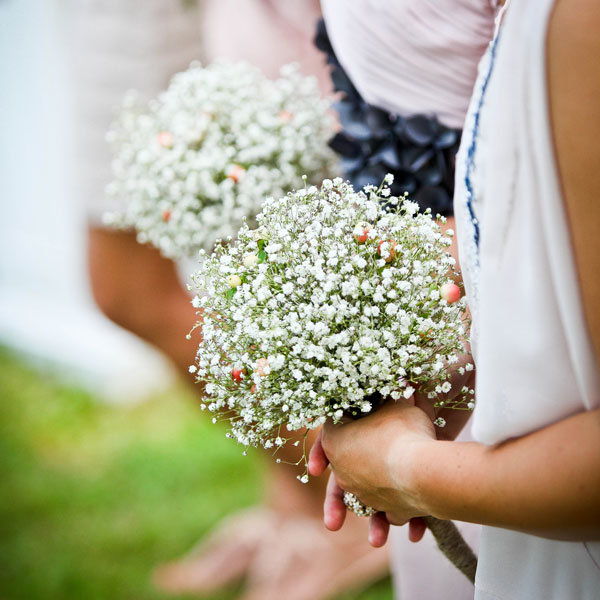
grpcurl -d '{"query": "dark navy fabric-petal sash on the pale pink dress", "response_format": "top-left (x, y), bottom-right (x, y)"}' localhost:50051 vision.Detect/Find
top-left (315, 20), bottom-right (461, 216)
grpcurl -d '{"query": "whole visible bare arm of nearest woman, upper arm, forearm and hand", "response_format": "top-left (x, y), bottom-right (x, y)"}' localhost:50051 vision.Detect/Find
top-left (310, 0), bottom-right (600, 546)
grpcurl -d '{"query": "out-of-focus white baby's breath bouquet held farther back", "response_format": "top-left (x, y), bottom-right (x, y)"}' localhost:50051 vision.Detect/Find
top-left (105, 62), bottom-right (335, 258)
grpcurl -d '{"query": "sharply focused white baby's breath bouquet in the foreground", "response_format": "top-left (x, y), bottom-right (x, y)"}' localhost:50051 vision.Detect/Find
top-left (191, 175), bottom-right (472, 464)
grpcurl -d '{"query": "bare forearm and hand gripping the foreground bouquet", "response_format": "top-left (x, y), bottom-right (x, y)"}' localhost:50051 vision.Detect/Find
top-left (310, 402), bottom-right (600, 546)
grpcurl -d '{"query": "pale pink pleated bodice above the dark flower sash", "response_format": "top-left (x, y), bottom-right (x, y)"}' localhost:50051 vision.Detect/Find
top-left (321, 0), bottom-right (496, 128)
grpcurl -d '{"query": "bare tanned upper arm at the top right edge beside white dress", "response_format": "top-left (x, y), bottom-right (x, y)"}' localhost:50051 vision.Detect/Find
top-left (547, 0), bottom-right (600, 364)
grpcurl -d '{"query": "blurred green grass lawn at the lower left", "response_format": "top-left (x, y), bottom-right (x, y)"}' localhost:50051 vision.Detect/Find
top-left (0, 349), bottom-right (392, 600)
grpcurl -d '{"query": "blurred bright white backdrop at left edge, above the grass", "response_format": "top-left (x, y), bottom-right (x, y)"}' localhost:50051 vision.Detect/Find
top-left (0, 0), bottom-right (173, 402)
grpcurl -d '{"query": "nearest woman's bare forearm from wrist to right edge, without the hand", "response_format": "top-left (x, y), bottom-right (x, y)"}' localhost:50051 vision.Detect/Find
top-left (408, 410), bottom-right (600, 540)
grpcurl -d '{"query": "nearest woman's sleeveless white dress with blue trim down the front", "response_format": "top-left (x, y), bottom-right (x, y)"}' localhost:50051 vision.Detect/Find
top-left (455, 0), bottom-right (600, 600)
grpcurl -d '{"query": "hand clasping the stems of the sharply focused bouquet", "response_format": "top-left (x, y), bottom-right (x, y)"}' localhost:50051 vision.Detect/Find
top-left (309, 400), bottom-right (435, 546)
